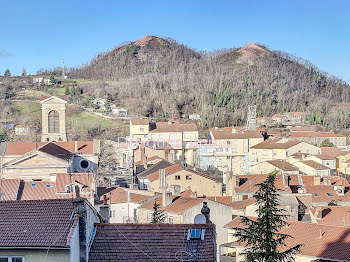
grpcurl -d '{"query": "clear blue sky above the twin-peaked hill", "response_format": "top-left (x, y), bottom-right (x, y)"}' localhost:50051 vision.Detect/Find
top-left (0, 0), bottom-right (350, 82)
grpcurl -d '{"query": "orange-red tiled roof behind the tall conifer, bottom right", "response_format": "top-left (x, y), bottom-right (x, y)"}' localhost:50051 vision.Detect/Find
top-left (226, 217), bottom-right (350, 261)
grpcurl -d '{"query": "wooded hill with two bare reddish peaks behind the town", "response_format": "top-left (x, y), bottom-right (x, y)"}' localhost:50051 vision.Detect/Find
top-left (70, 36), bottom-right (350, 130)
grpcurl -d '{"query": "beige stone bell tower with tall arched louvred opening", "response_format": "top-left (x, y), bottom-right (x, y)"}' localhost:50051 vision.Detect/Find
top-left (40, 96), bottom-right (67, 142)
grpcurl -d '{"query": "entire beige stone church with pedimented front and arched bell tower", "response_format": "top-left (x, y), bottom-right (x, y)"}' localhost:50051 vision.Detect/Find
top-left (0, 96), bottom-right (100, 181)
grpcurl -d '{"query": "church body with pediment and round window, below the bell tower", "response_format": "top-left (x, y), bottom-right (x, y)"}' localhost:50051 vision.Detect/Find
top-left (0, 140), bottom-right (100, 181)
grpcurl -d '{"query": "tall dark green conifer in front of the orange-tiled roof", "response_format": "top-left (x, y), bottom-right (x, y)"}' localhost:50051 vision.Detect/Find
top-left (234, 172), bottom-right (301, 262)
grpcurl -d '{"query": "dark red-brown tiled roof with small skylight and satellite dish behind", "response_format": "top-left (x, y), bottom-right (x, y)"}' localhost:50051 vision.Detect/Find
top-left (89, 224), bottom-right (216, 262)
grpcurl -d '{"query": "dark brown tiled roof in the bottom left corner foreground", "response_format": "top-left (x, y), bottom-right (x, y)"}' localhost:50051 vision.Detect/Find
top-left (0, 199), bottom-right (74, 248)
